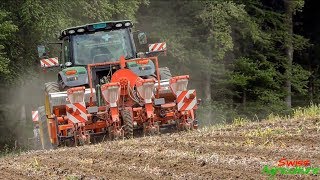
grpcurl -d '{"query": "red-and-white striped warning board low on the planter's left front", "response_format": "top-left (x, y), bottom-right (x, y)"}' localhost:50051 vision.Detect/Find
top-left (66, 102), bottom-right (88, 123)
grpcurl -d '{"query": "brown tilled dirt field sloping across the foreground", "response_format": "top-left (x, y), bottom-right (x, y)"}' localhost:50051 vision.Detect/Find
top-left (0, 117), bottom-right (320, 179)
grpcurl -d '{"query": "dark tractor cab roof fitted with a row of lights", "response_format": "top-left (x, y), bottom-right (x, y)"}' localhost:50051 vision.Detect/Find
top-left (59, 20), bottom-right (133, 40)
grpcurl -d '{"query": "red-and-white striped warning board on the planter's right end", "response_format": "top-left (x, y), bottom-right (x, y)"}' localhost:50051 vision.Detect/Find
top-left (177, 89), bottom-right (197, 111)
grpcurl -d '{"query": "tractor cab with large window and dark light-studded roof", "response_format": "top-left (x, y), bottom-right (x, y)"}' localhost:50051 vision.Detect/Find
top-left (59, 21), bottom-right (137, 66)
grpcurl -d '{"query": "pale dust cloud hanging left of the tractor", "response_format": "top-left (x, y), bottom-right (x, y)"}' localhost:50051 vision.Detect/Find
top-left (0, 69), bottom-right (56, 151)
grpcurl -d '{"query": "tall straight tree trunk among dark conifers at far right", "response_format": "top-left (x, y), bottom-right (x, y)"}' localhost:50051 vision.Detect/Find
top-left (284, 0), bottom-right (293, 108)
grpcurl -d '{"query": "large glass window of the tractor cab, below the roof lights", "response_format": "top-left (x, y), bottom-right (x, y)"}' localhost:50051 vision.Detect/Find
top-left (73, 29), bottom-right (133, 65)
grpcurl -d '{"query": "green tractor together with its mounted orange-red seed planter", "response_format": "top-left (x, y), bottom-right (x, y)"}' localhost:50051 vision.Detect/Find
top-left (33, 20), bottom-right (197, 149)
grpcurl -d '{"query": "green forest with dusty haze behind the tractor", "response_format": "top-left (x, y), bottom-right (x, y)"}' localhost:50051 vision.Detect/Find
top-left (0, 0), bottom-right (320, 149)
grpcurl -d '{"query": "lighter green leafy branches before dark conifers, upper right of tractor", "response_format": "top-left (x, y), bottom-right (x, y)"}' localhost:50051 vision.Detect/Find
top-left (199, 1), bottom-right (260, 60)
